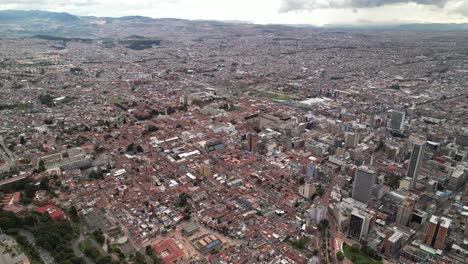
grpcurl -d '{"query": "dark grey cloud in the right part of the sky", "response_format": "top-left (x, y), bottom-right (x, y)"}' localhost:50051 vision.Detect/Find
top-left (280, 0), bottom-right (449, 13)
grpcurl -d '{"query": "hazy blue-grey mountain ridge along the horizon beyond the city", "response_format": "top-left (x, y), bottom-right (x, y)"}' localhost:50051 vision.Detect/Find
top-left (0, 10), bottom-right (468, 38)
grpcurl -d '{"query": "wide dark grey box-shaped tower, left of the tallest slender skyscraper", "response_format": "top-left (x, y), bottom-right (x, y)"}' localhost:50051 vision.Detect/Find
top-left (352, 166), bottom-right (375, 204)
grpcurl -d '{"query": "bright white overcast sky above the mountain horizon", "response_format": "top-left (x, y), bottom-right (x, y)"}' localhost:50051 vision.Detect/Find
top-left (0, 0), bottom-right (468, 25)
